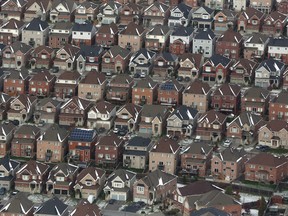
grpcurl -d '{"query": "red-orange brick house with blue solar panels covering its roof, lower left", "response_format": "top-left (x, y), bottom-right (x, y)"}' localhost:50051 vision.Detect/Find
top-left (68, 128), bottom-right (97, 162)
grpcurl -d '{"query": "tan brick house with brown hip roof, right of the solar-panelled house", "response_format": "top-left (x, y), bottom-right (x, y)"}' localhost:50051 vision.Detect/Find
top-left (182, 80), bottom-right (212, 113)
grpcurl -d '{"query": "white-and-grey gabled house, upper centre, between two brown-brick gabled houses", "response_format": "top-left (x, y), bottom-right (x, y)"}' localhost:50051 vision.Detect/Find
top-left (129, 48), bottom-right (156, 77)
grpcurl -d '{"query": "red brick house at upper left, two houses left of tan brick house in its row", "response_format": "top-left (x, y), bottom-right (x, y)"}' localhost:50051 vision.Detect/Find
top-left (29, 71), bottom-right (56, 96)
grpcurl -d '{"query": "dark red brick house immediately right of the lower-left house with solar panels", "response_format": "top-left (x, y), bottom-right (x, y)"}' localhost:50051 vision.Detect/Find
top-left (95, 133), bottom-right (124, 168)
